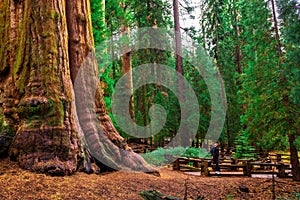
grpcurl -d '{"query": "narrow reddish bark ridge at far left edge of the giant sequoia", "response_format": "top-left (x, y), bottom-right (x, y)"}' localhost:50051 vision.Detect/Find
top-left (0, 0), bottom-right (13, 156)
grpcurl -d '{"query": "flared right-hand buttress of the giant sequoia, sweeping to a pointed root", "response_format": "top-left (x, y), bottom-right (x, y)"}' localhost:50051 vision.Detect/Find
top-left (67, 1), bottom-right (157, 173)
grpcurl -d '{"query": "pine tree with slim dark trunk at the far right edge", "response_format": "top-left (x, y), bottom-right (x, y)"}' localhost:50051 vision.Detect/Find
top-left (276, 0), bottom-right (300, 181)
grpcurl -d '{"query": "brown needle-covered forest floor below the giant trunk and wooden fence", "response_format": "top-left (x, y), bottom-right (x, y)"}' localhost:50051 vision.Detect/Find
top-left (0, 159), bottom-right (300, 200)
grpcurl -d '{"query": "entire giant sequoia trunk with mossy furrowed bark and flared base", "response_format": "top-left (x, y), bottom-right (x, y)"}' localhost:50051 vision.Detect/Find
top-left (0, 0), bottom-right (155, 175)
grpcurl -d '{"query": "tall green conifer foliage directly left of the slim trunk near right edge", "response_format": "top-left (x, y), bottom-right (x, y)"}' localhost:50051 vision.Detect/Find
top-left (239, 0), bottom-right (286, 150)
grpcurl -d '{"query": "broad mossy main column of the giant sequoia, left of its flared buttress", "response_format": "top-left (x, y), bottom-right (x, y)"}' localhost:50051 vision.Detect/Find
top-left (1, 0), bottom-right (81, 175)
